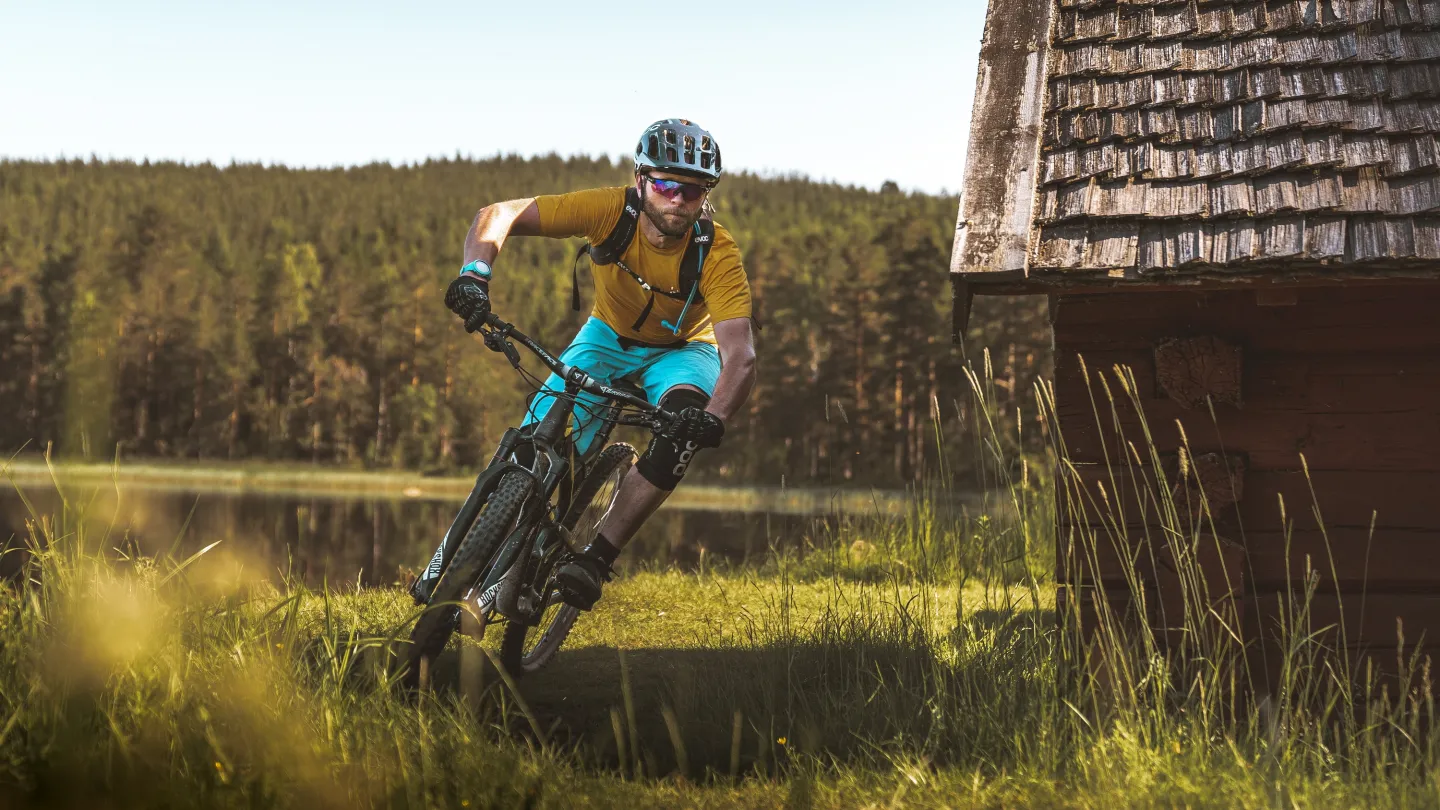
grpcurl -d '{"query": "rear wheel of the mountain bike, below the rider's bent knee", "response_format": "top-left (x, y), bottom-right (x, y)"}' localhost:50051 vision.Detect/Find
top-left (500, 442), bottom-right (635, 679)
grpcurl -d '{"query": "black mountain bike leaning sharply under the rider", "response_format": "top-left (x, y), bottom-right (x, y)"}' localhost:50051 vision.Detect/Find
top-left (403, 313), bottom-right (678, 687)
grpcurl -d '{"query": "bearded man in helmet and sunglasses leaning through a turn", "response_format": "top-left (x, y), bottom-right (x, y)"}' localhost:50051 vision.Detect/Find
top-left (445, 118), bottom-right (756, 610)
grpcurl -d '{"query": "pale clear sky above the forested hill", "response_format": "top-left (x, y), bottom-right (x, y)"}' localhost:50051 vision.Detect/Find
top-left (0, 0), bottom-right (986, 193)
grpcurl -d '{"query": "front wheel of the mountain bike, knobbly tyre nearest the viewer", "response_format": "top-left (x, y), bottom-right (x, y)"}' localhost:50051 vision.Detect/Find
top-left (405, 473), bottom-right (531, 689)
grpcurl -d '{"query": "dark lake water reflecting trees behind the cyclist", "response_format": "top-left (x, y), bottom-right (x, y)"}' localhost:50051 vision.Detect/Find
top-left (0, 486), bottom-right (834, 587)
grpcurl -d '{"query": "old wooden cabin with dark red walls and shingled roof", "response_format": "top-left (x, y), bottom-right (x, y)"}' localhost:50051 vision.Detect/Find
top-left (952, 0), bottom-right (1440, 680)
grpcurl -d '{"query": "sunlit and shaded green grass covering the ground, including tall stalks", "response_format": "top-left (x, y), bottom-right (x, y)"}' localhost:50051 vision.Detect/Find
top-left (0, 363), bottom-right (1440, 809)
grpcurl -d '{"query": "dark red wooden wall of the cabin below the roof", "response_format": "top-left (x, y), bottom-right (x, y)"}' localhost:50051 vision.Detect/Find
top-left (1051, 282), bottom-right (1440, 677)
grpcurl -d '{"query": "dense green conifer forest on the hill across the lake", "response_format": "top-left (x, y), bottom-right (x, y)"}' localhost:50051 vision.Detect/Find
top-left (0, 157), bottom-right (1048, 486)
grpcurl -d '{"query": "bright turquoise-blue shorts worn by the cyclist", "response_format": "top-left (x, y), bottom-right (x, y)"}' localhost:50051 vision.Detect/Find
top-left (523, 317), bottom-right (720, 454)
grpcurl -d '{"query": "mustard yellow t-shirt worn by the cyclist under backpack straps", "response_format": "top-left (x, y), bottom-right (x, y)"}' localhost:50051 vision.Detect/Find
top-left (536, 187), bottom-right (750, 343)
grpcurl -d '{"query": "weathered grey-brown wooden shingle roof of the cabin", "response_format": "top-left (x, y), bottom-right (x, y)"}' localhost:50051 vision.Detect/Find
top-left (955, 0), bottom-right (1440, 286)
